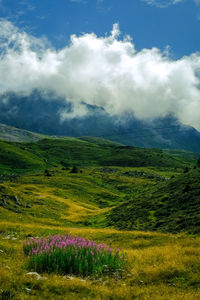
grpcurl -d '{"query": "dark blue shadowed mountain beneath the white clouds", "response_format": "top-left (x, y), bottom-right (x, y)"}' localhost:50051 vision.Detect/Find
top-left (0, 90), bottom-right (200, 152)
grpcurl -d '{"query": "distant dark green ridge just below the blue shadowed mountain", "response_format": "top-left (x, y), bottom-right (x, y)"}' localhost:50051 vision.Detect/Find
top-left (0, 138), bottom-right (188, 177)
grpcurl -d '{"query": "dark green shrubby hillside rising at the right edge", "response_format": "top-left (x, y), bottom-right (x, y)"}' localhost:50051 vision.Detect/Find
top-left (107, 170), bottom-right (200, 233)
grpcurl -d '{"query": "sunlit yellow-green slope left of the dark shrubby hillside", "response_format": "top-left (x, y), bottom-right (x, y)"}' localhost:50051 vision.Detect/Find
top-left (0, 169), bottom-right (117, 226)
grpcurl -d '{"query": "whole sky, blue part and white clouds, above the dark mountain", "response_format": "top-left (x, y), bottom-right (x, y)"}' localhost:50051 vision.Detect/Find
top-left (0, 0), bottom-right (200, 130)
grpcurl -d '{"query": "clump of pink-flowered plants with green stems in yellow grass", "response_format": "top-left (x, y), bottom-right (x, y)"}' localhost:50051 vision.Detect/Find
top-left (23, 235), bottom-right (126, 276)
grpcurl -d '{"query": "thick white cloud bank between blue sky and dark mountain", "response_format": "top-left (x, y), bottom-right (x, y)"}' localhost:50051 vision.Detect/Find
top-left (0, 20), bottom-right (200, 130)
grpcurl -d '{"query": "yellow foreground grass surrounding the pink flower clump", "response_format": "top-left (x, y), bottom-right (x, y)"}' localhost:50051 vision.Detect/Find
top-left (0, 222), bottom-right (200, 300)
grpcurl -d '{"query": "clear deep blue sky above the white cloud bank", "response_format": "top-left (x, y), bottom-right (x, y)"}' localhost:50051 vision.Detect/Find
top-left (0, 0), bottom-right (200, 58)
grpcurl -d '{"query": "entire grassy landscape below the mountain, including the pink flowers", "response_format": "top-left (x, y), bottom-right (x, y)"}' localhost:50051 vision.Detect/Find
top-left (0, 138), bottom-right (200, 300)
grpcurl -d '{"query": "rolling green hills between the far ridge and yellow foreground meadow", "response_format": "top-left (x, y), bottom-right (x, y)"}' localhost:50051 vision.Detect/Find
top-left (0, 167), bottom-right (200, 233)
